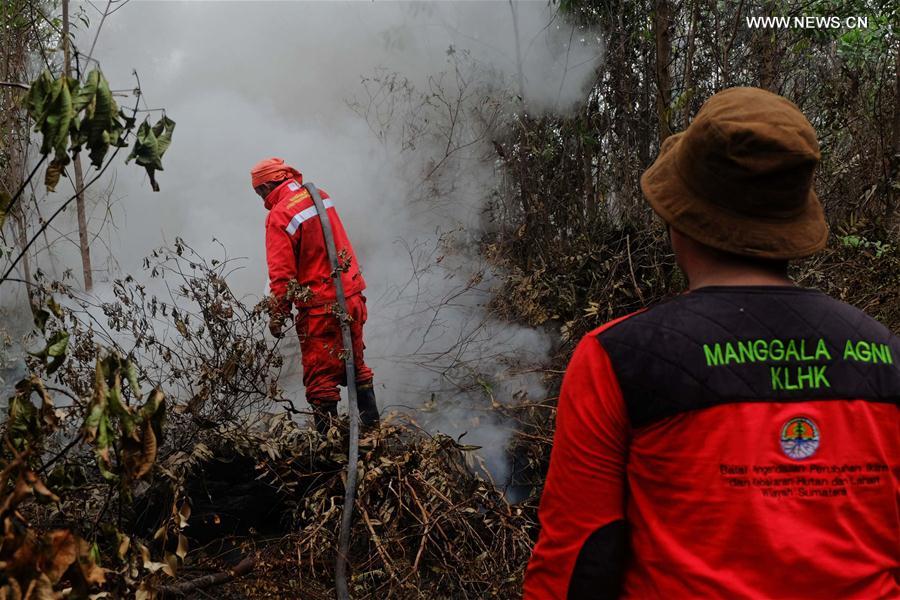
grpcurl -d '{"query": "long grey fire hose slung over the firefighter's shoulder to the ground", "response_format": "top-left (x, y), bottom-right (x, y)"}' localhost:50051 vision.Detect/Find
top-left (303, 182), bottom-right (359, 600)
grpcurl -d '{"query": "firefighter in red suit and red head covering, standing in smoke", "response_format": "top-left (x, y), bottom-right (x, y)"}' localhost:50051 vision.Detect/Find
top-left (250, 158), bottom-right (379, 432)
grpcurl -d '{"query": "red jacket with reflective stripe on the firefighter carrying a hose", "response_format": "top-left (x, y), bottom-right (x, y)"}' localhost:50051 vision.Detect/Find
top-left (265, 178), bottom-right (366, 307)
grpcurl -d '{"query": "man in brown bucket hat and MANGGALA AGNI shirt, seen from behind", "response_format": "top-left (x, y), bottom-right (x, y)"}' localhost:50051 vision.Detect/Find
top-left (525, 88), bottom-right (900, 600)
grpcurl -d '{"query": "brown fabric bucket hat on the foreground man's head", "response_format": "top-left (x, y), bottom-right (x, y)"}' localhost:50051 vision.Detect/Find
top-left (641, 87), bottom-right (828, 259)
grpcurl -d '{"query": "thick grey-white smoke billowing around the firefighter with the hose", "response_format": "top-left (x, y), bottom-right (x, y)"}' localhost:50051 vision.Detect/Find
top-left (4, 1), bottom-right (600, 477)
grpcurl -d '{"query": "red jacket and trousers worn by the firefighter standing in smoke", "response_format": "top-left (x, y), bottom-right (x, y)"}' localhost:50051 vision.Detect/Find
top-left (265, 173), bottom-right (372, 404)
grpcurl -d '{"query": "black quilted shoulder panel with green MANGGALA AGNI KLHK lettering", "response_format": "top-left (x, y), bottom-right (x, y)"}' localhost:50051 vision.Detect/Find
top-left (597, 286), bottom-right (900, 427)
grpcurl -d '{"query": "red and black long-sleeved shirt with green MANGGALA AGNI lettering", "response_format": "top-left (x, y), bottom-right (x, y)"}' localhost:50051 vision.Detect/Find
top-left (525, 286), bottom-right (900, 600)
